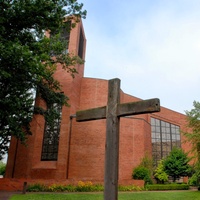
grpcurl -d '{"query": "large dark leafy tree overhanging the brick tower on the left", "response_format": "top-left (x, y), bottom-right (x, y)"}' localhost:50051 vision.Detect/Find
top-left (0, 0), bottom-right (86, 159)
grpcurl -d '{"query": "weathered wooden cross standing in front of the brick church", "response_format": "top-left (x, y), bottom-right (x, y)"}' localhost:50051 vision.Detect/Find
top-left (76, 79), bottom-right (160, 200)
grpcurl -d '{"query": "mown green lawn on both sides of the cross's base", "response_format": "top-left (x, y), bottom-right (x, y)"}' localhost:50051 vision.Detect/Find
top-left (10, 191), bottom-right (200, 200)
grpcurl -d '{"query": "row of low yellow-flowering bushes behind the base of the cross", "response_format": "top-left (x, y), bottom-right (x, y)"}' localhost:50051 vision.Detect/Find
top-left (27, 181), bottom-right (144, 192)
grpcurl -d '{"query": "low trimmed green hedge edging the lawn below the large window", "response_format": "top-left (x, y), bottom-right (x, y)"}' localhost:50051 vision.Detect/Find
top-left (145, 184), bottom-right (189, 191)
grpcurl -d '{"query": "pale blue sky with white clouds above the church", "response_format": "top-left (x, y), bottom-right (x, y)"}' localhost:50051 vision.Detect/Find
top-left (79, 0), bottom-right (200, 114)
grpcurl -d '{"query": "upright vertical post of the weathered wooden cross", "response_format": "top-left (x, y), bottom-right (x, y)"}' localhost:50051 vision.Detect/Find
top-left (104, 79), bottom-right (120, 200)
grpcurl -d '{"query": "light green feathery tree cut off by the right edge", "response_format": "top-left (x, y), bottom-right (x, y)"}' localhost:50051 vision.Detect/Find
top-left (183, 101), bottom-right (200, 185)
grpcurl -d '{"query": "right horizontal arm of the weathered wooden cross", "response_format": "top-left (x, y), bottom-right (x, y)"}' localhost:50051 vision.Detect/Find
top-left (117, 98), bottom-right (160, 117)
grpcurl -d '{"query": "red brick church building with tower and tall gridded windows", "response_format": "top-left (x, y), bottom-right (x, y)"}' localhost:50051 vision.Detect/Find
top-left (5, 19), bottom-right (189, 186)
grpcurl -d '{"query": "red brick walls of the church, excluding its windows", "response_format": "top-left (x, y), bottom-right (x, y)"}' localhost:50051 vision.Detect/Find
top-left (6, 18), bottom-right (190, 188)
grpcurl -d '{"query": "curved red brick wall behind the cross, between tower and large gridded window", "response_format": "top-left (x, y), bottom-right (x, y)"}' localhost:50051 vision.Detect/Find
top-left (69, 78), bottom-right (151, 180)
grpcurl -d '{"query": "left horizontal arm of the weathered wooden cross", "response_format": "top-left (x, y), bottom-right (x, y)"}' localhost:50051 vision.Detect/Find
top-left (76, 106), bottom-right (106, 122)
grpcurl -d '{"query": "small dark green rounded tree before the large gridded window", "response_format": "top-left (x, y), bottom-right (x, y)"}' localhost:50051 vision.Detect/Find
top-left (163, 148), bottom-right (191, 182)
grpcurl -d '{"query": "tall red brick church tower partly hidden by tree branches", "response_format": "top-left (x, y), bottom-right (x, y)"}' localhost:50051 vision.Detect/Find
top-left (5, 18), bottom-right (86, 179)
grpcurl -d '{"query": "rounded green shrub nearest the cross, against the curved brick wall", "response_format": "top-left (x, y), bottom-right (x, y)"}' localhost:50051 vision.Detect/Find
top-left (132, 166), bottom-right (152, 184)
